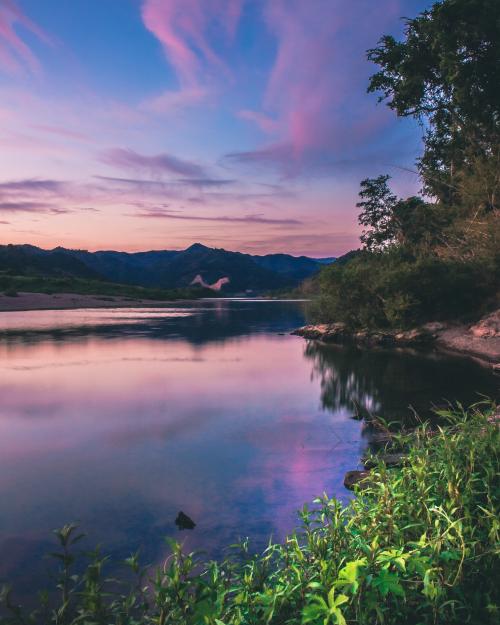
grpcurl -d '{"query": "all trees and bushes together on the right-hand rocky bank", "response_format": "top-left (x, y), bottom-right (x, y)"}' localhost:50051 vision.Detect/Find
top-left (314, 0), bottom-right (500, 328)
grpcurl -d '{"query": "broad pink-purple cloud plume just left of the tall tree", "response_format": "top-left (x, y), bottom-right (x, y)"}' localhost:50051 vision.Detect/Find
top-left (227, 0), bottom-right (400, 175)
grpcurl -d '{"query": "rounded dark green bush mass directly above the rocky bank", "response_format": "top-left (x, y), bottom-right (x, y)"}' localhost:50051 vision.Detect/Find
top-left (312, 249), bottom-right (500, 328)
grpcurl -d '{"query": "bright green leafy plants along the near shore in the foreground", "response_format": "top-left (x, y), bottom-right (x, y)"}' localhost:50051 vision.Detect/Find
top-left (1, 403), bottom-right (500, 625)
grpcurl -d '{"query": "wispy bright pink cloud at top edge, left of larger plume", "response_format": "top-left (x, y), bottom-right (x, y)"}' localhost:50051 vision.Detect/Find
top-left (142, 0), bottom-right (243, 87)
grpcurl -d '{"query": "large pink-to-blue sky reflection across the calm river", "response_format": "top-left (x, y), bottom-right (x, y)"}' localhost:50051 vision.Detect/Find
top-left (0, 312), bottom-right (360, 588)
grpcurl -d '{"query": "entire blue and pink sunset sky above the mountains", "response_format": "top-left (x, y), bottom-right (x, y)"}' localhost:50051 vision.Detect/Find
top-left (0, 0), bottom-right (431, 256)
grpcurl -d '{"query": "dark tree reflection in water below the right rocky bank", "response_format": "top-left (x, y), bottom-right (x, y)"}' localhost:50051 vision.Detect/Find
top-left (305, 341), bottom-right (498, 421)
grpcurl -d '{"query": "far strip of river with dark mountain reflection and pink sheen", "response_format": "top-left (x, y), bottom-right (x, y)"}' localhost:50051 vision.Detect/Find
top-left (0, 299), bottom-right (304, 345)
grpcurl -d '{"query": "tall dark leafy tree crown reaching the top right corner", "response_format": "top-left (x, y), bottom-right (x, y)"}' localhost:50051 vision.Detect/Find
top-left (368, 0), bottom-right (500, 205)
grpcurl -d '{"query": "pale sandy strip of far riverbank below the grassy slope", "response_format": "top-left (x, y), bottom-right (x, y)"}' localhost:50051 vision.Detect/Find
top-left (0, 293), bottom-right (193, 313)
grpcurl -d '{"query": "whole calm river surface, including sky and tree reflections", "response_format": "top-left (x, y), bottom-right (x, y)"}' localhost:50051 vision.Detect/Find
top-left (0, 300), bottom-right (498, 585)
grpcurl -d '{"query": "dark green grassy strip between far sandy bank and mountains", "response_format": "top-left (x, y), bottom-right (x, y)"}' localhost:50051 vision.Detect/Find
top-left (0, 274), bottom-right (214, 301)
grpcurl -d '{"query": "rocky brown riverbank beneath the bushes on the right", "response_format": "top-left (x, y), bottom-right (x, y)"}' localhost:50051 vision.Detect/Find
top-left (292, 310), bottom-right (500, 369)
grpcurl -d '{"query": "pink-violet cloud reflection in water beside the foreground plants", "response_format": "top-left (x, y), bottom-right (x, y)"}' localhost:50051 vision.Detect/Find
top-left (232, 406), bottom-right (362, 539)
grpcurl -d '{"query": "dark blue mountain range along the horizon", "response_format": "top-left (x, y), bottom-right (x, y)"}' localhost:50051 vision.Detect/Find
top-left (0, 243), bottom-right (336, 293)
